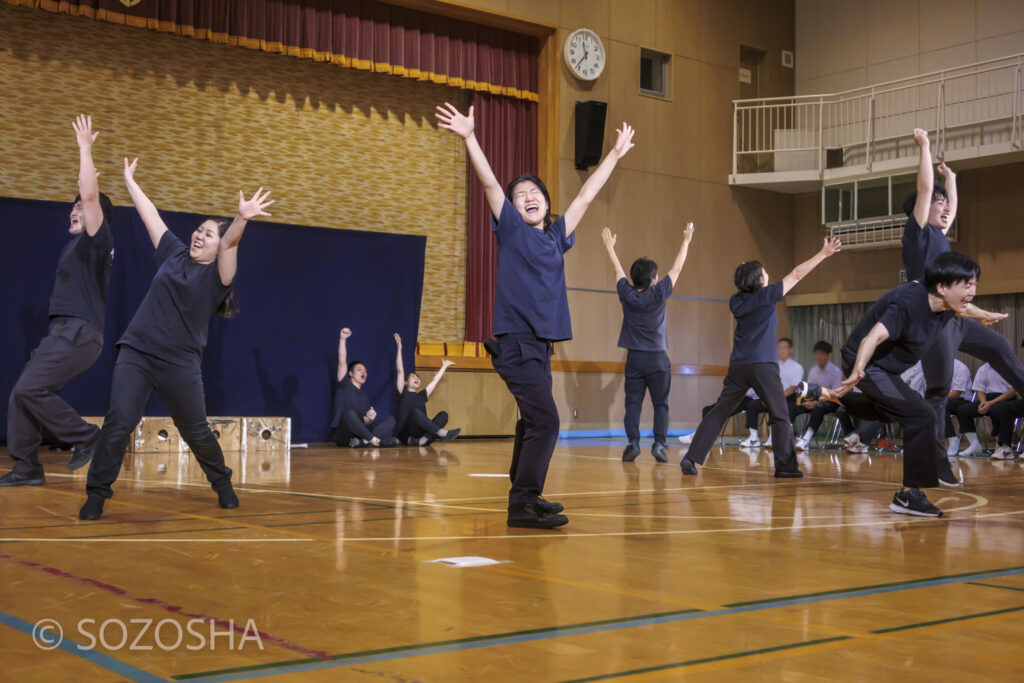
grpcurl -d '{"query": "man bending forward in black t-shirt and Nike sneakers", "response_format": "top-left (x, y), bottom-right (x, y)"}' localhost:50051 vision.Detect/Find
top-left (837, 252), bottom-right (981, 517)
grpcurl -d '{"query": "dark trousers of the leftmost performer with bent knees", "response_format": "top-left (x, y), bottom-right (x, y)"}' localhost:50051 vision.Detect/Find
top-left (7, 317), bottom-right (103, 476)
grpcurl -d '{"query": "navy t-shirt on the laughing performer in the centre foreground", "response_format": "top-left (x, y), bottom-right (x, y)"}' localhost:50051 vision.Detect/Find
top-left (490, 200), bottom-right (575, 341)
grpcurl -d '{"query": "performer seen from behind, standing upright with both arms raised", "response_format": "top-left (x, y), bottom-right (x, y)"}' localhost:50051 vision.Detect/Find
top-left (601, 223), bottom-right (693, 463)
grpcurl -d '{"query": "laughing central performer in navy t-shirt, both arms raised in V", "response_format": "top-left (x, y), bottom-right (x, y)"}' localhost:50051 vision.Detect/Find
top-left (436, 103), bottom-right (633, 528)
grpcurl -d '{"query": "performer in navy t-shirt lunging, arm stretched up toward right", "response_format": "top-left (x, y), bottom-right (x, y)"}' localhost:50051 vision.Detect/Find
top-left (680, 238), bottom-right (842, 478)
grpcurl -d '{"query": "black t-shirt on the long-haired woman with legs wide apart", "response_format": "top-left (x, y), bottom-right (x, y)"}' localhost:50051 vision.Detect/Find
top-left (118, 230), bottom-right (230, 367)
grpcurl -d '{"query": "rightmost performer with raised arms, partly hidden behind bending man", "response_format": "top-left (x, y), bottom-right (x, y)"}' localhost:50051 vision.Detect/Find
top-left (903, 128), bottom-right (1024, 486)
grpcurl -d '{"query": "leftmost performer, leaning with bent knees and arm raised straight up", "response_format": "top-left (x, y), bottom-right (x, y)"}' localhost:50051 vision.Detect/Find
top-left (0, 116), bottom-right (114, 486)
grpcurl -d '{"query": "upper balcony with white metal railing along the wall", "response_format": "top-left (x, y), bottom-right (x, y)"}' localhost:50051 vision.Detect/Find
top-left (729, 53), bottom-right (1024, 194)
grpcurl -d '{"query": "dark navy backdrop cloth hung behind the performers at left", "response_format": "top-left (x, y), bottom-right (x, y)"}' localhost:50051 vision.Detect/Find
top-left (0, 198), bottom-right (426, 441)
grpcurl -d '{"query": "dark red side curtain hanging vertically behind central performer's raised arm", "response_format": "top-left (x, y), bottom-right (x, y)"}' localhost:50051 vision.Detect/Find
top-left (466, 92), bottom-right (543, 341)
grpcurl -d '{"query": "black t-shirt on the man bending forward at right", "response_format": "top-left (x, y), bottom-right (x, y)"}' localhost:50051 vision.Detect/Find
top-left (842, 282), bottom-right (953, 375)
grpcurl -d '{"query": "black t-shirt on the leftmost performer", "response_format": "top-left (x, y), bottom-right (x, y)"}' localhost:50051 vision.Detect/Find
top-left (49, 219), bottom-right (114, 330)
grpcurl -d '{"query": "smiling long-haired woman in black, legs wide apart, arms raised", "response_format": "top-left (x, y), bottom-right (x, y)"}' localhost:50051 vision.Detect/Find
top-left (78, 159), bottom-right (273, 519)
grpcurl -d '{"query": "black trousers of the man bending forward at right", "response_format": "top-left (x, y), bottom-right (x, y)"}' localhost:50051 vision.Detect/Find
top-left (843, 361), bottom-right (937, 488)
